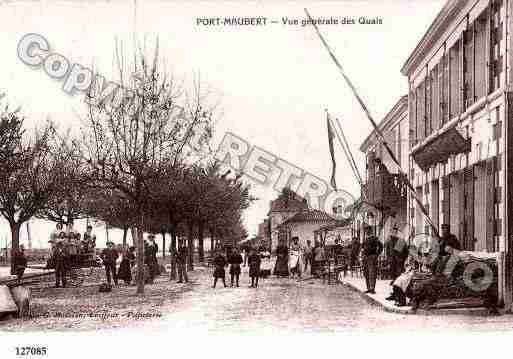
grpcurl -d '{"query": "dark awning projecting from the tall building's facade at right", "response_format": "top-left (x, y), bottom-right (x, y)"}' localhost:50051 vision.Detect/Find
top-left (412, 127), bottom-right (471, 171)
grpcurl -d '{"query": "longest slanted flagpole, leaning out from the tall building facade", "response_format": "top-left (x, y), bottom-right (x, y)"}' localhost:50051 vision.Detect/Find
top-left (304, 8), bottom-right (439, 236)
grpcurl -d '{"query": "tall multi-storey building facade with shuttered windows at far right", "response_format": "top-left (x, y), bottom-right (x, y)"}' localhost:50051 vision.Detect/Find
top-left (401, 0), bottom-right (513, 306)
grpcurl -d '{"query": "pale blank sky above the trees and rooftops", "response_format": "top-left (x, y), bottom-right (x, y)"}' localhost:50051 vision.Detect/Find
top-left (0, 0), bottom-right (444, 247)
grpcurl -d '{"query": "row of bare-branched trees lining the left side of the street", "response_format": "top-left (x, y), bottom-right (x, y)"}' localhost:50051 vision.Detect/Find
top-left (0, 42), bottom-right (253, 294)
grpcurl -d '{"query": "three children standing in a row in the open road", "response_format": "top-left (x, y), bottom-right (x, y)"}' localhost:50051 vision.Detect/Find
top-left (212, 248), bottom-right (261, 288)
